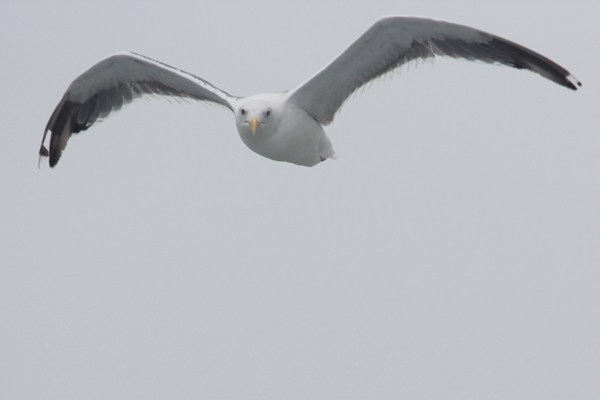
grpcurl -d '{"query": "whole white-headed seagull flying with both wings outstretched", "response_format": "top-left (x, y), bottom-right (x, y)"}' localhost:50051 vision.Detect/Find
top-left (39, 16), bottom-right (581, 167)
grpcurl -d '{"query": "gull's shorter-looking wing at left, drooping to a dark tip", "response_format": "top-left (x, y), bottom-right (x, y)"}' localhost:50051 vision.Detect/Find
top-left (40, 52), bottom-right (235, 167)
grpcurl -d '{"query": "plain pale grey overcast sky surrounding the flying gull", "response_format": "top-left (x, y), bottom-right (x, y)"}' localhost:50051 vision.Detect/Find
top-left (0, 0), bottom-right (600, 400)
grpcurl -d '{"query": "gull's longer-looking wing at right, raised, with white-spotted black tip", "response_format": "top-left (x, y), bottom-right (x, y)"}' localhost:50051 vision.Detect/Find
top-left (288, 17), bottom-right (581, 125)
